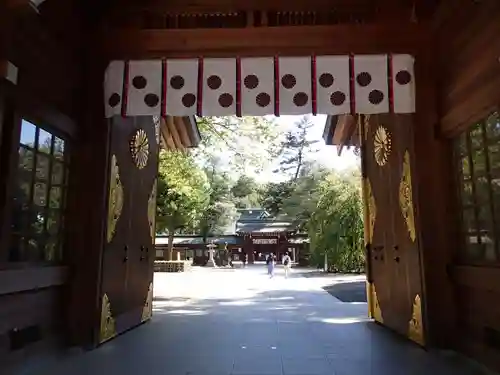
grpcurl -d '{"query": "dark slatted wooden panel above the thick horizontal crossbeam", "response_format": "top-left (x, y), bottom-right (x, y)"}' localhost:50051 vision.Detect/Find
top-left (102, 0), bottom-right (438, 29)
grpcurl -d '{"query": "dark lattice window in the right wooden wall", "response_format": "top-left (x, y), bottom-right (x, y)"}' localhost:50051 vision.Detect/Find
top-left (456, 112), bottom-right (500, 264)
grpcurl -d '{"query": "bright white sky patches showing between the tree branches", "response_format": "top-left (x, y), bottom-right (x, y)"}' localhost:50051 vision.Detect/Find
top-left (255, 115), bottom-right (360, 182)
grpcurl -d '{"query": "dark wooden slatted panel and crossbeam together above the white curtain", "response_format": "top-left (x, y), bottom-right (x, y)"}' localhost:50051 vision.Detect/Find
top-left (91, 0), bottom-right (439, 59)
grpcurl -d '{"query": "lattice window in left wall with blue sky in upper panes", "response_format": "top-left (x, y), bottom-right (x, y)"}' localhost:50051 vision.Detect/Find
top-left (9, 120), bottom-right (69, 263)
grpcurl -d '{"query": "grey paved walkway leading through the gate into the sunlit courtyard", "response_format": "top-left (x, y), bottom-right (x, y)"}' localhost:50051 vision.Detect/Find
top-left (37, 267), bottom-right (488, 375)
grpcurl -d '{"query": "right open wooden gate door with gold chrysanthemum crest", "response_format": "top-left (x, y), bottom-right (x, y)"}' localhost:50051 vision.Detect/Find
top-left (359, 115), bottom-right (425, 345)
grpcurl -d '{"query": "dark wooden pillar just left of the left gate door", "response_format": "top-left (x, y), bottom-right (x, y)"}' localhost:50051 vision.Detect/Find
top-left (66, 62), bottom-right (110, 347)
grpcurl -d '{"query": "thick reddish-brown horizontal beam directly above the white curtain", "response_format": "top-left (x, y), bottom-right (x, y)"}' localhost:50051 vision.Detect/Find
top-left (102, 22), bottom-right (429, 59)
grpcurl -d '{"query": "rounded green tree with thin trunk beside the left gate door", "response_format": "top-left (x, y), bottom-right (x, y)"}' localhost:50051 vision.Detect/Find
top-left (156, 150), bottom-right (210, 260)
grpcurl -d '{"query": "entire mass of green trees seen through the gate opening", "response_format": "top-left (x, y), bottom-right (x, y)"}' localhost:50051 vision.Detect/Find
top-left (157, 117), bottom-right (364, 272)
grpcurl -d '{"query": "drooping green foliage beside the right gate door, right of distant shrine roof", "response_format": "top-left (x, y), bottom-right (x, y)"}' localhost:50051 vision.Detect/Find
top-left (262, 166), bottom-right (364, 272)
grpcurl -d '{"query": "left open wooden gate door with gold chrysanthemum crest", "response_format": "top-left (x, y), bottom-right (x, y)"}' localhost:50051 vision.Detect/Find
top-left (97, 117), bottom-right (159, 343)
